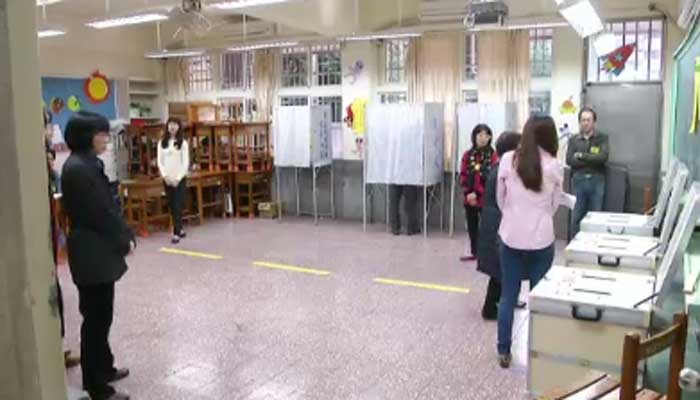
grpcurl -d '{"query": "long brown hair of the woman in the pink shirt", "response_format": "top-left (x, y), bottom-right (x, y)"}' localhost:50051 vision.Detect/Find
top-left (513, 115), bottom-right (559, 192)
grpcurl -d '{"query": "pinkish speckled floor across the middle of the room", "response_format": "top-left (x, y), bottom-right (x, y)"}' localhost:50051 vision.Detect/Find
top-left (61, 219), bottom-right (564, 400)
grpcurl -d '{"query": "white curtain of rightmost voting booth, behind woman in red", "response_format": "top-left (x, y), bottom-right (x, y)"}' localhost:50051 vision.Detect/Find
top-left (457, 103), bottom-right (520, 159)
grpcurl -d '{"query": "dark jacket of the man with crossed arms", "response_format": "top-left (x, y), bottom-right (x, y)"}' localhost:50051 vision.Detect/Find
top-left (566, 132), bottom-right (610, 175)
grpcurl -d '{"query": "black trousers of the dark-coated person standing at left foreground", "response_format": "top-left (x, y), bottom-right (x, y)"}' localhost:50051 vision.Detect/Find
top-left (78, 283), bottom-right (115, 400)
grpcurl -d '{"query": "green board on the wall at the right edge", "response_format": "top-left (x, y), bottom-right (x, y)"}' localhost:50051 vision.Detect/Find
top-left (670, 17), bottom-right (700, 180)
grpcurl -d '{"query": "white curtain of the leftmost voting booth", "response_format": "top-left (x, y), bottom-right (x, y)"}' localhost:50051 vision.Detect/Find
top-left (273, 106), bottom-right (333, 168)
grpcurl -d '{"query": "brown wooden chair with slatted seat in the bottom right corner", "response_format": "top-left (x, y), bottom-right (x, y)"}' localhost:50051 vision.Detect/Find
top-left (540, 314), bottom-right (688, 400)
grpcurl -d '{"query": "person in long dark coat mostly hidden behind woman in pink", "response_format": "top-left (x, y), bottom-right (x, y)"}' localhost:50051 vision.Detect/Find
top-left (476, 132), bottom-right (520, 321)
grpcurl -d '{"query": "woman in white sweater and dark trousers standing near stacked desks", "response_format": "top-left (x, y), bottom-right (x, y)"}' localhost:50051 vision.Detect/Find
top-left (158, 118), bottom-right (190, 244)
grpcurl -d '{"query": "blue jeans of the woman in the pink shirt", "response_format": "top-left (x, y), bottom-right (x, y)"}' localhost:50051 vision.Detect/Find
top-left (498, 243), bottom-right (554, 354)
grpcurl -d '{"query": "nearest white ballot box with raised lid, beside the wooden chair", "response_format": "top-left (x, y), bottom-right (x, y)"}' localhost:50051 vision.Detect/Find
top-left (528, 183), bottom-right (700, 395)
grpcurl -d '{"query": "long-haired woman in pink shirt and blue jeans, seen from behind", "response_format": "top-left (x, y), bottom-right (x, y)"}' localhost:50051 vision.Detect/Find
top-left (496, 115), bottom-right (563, 368)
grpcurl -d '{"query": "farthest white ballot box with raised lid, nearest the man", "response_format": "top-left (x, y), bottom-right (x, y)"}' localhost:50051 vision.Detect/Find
top-left (581, 158), bottom-right (688, 236)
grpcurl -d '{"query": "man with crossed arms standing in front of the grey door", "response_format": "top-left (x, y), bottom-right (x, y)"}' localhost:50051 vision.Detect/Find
top-left (566, 107), bottom-right (610, 235)
